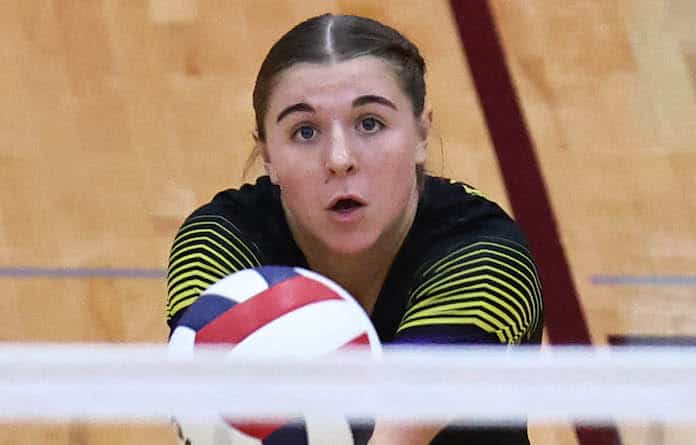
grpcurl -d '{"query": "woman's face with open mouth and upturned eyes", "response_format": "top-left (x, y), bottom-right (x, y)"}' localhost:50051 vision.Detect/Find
top-left (261, 56), bottom-right (430, 254)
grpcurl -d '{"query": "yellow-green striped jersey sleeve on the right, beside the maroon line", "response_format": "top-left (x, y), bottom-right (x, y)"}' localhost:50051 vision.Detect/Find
top-left (396, 238), bottom-right (543, 344)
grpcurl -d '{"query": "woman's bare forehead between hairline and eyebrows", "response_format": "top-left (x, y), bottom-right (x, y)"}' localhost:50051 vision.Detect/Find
top-left (269, 56), bottom-right (408, 110)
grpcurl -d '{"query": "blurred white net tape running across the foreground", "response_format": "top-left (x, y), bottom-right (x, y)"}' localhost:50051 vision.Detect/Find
top-left (0, 343), bottom-right (696, 424)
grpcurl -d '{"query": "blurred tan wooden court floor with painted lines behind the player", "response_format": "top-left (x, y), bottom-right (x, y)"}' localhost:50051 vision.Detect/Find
top-left (0, 0), bottom-right (696, 445)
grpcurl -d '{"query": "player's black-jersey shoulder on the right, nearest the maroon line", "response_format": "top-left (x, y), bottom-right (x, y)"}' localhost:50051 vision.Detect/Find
top-left (399, 178), bottom-right (543, 344)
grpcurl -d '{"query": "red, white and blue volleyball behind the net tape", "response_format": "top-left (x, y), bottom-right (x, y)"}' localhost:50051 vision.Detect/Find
top-left (169, 266), bottom-right (382, 445)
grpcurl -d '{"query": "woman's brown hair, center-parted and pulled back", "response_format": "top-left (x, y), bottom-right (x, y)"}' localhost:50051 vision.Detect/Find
top-left (244, 14), bottom-right (425, 188)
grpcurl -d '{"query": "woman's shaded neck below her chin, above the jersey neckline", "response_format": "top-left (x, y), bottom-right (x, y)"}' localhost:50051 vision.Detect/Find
top-left (290, 187), bottom-right (418, 313)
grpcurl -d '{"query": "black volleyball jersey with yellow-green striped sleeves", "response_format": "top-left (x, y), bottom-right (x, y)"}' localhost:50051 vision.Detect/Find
top-left (167, 176), bottom-right (543, 444)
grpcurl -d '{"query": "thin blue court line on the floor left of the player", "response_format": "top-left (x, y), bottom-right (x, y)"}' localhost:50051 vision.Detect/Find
top-left (0, 266), bottom-right (167, 279)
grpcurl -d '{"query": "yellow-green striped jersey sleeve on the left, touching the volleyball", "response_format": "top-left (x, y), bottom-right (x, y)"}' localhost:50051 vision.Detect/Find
top-left (166, 215), bottom-right (261, 327)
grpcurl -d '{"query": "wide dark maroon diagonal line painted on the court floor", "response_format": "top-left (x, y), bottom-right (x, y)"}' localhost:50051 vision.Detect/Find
top-left (450, 0), bottom-right (621, 445)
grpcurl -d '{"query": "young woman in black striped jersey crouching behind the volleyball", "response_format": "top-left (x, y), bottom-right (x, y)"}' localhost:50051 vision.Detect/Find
top-left (168, 14), bottom-right (543, 445)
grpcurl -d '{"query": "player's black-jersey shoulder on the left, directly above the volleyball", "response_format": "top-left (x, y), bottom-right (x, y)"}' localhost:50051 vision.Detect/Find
top-left (167, 177), bottom-right (287, 326)
